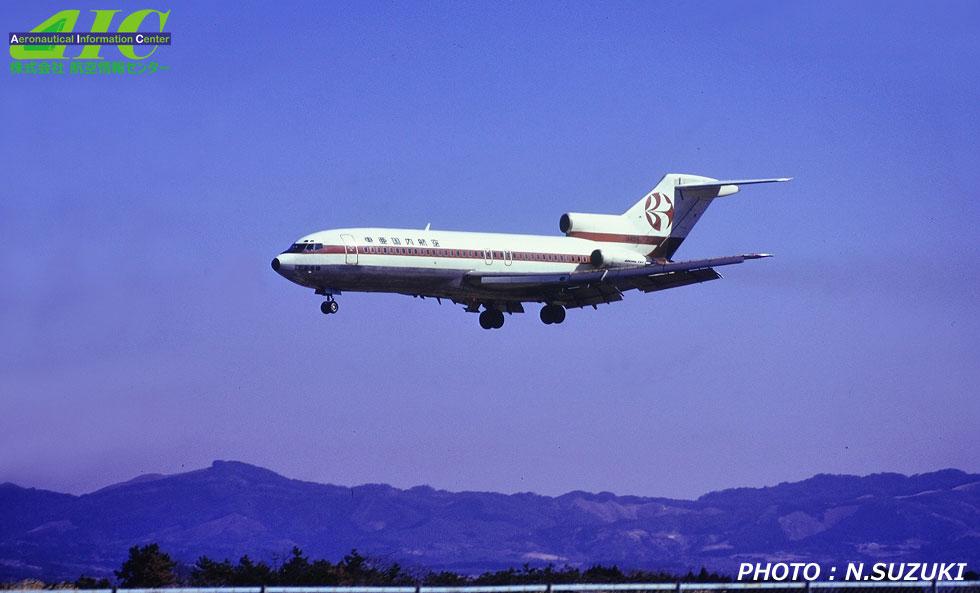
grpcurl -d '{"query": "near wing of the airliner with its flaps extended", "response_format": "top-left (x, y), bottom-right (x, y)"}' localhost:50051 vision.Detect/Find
top-left (466, 253), bottom-right (771, 308)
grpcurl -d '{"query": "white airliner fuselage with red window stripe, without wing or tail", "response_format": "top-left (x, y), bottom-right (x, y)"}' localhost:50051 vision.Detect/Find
top-left (273, 228), bottom-right (647, 299)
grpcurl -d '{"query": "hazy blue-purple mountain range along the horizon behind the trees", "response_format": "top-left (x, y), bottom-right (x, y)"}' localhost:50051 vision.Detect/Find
top-left (0, 461), bottom-right (980, 581)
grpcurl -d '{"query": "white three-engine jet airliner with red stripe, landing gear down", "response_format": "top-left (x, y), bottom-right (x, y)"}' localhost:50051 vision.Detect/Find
top-left (272, 173), bottom-right (791, 329)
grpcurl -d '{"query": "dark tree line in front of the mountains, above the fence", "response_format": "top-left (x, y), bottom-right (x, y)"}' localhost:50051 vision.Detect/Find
top-left (67, 544), bottom-right (731, 589)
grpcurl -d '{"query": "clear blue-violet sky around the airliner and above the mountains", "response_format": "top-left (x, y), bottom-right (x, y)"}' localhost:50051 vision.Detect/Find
top-left (0, 2), bottom-right (980, 497)
